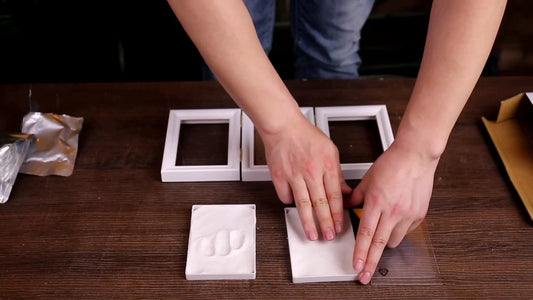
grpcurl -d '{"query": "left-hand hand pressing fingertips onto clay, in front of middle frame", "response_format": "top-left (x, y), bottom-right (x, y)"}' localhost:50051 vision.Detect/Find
top-left (262, 116), bottom-right (352, 241)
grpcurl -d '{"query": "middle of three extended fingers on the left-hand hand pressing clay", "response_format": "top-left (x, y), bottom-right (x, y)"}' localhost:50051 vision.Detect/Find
top-left (306, 177), bottom-right (334, 241)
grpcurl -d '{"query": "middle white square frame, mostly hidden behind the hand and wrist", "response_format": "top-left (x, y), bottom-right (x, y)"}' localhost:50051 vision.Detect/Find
top-left (241, 107), bottom-right (315, 181)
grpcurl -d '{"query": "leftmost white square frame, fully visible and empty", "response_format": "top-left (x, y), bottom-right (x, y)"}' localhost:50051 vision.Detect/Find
top-left (161, 108), bottom-right (241, 182)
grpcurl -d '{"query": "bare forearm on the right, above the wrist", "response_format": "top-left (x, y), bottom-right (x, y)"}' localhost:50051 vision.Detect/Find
top-left (396, 0), bottom-right (506, 159)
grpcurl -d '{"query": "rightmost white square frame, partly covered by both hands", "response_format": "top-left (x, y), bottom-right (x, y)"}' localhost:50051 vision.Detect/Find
top-left (315, 105), bottom-right (394, 179)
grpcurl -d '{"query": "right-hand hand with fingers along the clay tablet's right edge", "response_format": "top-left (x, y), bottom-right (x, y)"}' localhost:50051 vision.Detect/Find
top-left (346, 143), bottom-right (438, 284)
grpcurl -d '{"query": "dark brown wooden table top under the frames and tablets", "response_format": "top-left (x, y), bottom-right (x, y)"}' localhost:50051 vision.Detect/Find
top-left (0, 77), bottom-right (533, 299)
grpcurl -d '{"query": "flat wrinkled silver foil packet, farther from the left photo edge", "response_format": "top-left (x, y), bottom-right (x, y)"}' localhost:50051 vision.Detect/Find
top-left (20, 112), bottom-right (83, 176)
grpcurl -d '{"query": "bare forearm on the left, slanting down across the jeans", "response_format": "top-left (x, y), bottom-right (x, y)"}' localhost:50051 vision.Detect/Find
top-left (169, 0), bottom-right (303, 134)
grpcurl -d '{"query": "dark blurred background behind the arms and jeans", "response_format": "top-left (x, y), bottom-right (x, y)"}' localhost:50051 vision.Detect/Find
top-left (0, 0), bottom-right (533, 84)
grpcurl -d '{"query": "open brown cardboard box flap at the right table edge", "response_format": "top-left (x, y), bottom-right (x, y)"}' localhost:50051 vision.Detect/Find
top-left (482, 93), bottom-right (533, 220)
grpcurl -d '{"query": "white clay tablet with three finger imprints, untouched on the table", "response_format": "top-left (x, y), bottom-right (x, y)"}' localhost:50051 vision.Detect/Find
top-left (185, 204), bottom-right (256, 280)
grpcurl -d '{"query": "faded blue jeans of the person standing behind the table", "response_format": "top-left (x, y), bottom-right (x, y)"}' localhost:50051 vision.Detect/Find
top-left (204, 0), bottom-right (374, 79)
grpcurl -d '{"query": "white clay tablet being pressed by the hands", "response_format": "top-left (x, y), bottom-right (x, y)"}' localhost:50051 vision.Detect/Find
top-left (285, 207), bottom-right (357, 283)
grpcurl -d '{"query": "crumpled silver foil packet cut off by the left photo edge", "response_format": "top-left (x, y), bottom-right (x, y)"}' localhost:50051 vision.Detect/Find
top-left (0, 134), bottom-right (33, 203)
